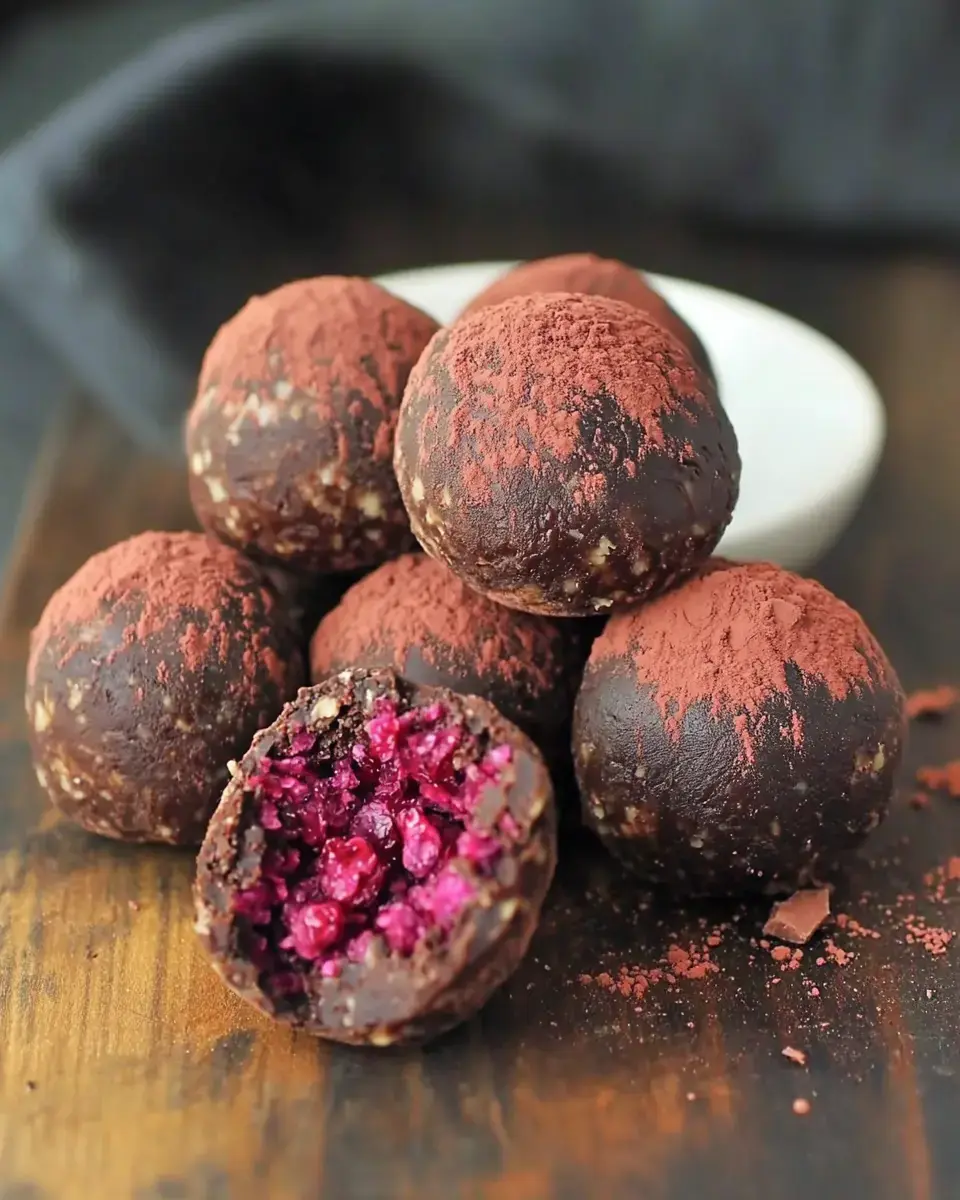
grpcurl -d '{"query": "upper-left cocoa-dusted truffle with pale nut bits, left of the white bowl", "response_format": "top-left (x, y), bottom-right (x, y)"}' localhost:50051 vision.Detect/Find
top-left (186, 276), bottom-right (437, 574)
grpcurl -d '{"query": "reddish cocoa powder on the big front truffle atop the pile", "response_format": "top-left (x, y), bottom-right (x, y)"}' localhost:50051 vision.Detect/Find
top-left (410, 294), bottom-right (713, 504)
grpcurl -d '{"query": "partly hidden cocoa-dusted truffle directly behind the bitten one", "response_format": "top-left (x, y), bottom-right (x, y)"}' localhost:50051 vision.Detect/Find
top-left (310, 554), bottom-right (586, 773)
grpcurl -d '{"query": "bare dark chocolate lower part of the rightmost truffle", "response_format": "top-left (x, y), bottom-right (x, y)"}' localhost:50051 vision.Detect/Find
top-left (574, 660), bottom-right (904, 895)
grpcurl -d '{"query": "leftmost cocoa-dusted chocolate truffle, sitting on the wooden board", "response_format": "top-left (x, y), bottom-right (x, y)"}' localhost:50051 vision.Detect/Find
top-left (26, 533), bottom-right (304, 845)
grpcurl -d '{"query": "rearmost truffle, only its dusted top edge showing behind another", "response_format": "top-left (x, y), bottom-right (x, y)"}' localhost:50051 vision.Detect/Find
top-left (461, 254), bottom-right (716, 383)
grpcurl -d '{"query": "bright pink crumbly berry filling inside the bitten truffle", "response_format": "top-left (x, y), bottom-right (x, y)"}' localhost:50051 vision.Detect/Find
top-left (234, 701), bottom-right (517, 995)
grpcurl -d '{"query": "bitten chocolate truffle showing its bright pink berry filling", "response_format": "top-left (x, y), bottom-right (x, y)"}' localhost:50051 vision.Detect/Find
top-left (197, 670), bottom-right (557, 1046)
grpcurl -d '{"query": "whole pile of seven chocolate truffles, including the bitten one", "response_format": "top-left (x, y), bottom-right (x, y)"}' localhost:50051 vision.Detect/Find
top-left (26, 254), bottom-right (902, 1045)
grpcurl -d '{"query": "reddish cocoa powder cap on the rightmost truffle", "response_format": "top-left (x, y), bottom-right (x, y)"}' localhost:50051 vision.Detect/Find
top-left (593, 559), bottom-right (893, 739)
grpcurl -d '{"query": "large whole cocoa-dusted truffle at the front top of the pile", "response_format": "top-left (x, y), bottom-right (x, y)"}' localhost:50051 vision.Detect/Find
top-left (395, 288), bottom-right (740, 616)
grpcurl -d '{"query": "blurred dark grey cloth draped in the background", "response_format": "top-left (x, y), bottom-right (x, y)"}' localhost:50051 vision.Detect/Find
top-left (0, 0), bottom-right (960, 448)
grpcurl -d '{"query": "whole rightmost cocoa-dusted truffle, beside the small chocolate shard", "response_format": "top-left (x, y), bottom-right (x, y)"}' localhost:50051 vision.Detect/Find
top-left (574, 560), bottom-right (904, 895)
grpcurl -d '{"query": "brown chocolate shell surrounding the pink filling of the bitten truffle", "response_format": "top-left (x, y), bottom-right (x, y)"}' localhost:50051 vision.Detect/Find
top-left (196, 670), bottom-right (557, 1046)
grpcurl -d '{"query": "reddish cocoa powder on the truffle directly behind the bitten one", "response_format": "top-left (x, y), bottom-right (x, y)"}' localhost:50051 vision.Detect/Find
top-left (311, 554), bottom-right (563, 692)
